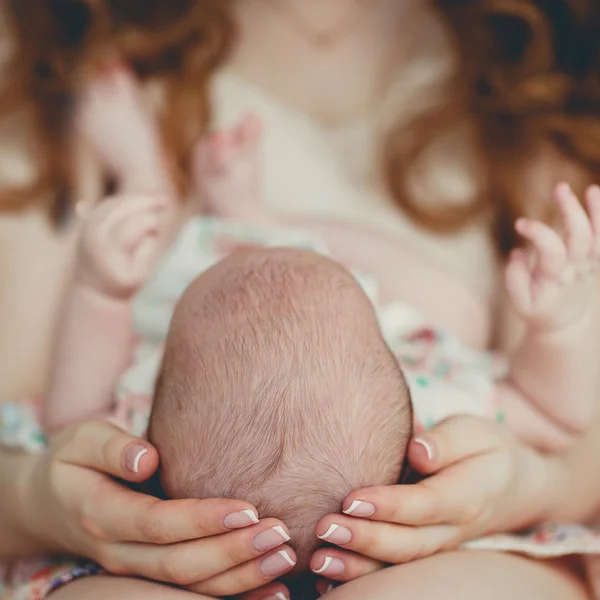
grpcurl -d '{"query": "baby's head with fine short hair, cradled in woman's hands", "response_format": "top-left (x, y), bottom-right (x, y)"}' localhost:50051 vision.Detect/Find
top-left (149, 249), bottom-right (412, 568)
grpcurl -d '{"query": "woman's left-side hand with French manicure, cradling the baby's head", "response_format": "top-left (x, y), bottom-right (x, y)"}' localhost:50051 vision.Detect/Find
top-left (23, 421), bottom-right (296, 596)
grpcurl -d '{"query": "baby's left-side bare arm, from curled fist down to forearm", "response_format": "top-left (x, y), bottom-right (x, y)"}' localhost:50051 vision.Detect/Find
top-left (43, 195), bottom-right (166, 431)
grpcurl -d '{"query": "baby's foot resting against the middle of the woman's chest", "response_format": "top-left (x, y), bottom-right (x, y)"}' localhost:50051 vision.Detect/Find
top-left (193, 116), bottom-right (266, 221)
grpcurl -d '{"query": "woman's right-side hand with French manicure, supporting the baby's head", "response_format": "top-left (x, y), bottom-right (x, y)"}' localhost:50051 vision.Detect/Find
top-left (311, 417), bottom-right (562, 581)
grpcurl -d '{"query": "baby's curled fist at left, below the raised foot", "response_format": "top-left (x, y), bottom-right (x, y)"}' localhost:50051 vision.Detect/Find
top-left (76, 194), bottom-right (167, 299)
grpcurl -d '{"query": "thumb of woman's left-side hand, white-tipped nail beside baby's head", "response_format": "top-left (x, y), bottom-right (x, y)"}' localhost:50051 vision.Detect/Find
top-left (51, 421), bottom-right (158, 482)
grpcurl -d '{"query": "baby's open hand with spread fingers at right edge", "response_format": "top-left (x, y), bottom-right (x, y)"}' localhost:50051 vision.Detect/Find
top-left (506, 184), bottom-right (600, 330)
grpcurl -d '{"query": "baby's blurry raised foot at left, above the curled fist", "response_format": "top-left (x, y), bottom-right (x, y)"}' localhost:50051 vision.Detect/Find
top-left (78, 64), bottom-right (170, 191)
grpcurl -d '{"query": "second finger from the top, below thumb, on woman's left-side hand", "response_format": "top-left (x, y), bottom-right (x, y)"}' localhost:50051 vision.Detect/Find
top-left (108, 519), bottom-right (291, 584)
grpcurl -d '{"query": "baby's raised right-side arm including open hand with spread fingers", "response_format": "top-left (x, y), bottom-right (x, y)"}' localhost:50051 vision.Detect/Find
top-left (499, 185), bottom-right (600, 449)
